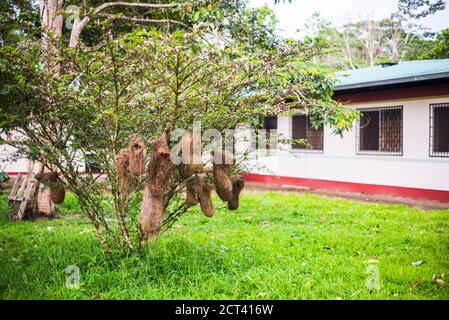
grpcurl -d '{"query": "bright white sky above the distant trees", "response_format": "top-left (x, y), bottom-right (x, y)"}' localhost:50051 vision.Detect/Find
top-left (249, 0), bottom-right (449, 38)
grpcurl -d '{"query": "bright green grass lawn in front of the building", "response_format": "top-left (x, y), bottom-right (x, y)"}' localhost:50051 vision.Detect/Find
top-left (0, 193), bottom-right (449, 299)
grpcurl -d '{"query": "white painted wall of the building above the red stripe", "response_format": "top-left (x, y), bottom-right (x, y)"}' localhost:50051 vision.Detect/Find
top-left (245, 96), bottom-right (449, 191)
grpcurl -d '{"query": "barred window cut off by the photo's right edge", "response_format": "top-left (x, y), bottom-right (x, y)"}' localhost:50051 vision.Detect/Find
top-left (430, 103), bottom-right (449, 157)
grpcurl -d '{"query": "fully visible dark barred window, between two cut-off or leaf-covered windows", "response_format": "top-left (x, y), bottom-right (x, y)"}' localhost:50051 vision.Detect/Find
top-left (356, 106), bottom-right (403, 156)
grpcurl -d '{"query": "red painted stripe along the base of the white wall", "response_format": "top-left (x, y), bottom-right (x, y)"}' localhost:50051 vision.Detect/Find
top-left (244, 173), bottom-right (449, 202)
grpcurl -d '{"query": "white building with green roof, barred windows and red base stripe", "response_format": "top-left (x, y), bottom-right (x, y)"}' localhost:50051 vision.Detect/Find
top-left (246, 60), bottom-right (449, 202)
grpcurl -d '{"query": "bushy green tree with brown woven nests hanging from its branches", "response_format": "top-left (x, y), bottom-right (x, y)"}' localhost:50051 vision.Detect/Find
top-left (0, 5), bottom-right (355, 251)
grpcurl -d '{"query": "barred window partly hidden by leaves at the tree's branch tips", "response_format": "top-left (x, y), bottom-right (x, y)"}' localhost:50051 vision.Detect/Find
top-left (292, 115), bottom-right (324, 151)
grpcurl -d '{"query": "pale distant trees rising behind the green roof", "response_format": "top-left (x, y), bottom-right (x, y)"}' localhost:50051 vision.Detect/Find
top-left (303, 0), bottom-right (446, 69)
